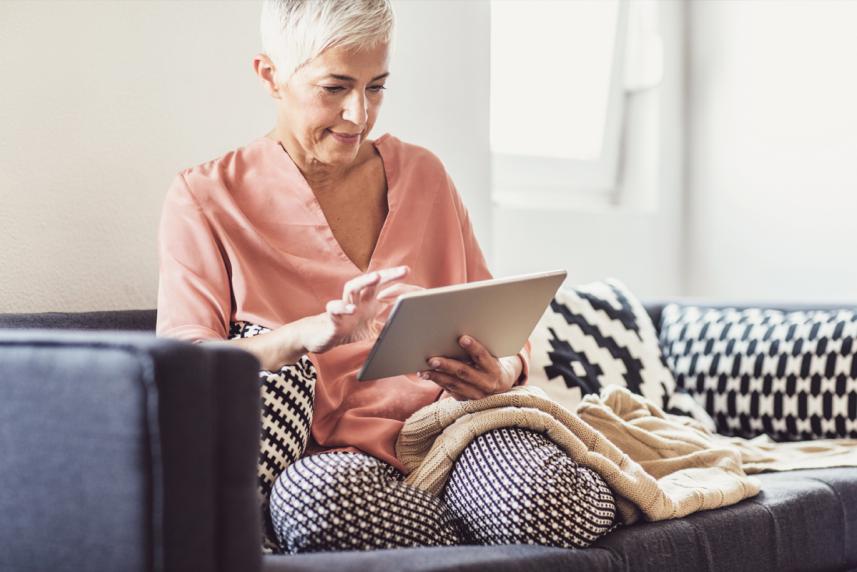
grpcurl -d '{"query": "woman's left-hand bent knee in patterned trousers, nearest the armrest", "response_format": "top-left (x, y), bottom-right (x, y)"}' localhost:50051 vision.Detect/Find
top-left (270, 453), bottom-right (458, 553)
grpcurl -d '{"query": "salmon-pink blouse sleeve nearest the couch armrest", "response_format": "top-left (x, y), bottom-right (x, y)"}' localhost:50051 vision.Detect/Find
top-left (156, 174), bottom-right (232, 343)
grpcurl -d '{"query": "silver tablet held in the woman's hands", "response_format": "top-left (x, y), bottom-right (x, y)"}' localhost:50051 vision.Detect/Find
top-left (357, 270), bottom-right (567, 381)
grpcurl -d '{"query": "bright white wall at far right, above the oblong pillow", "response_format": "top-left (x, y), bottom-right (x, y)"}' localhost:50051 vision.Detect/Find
top-left (686, 0), bottom-right (857, 302)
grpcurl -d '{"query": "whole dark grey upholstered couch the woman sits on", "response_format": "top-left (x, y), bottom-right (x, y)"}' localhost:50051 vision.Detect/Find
top-left (0, 303), bottom-right (857, 572)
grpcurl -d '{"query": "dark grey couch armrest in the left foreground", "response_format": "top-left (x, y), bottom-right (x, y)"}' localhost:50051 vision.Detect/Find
top-left (0, 330), bottom-right (261, 571)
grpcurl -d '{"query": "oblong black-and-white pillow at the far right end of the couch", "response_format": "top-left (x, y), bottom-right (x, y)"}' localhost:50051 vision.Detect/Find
top-left (661, 304), bottom-right (857, 440)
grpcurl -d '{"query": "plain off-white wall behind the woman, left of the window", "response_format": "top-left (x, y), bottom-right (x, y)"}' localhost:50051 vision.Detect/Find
top-left (0, 0), bottom-right (491, 312)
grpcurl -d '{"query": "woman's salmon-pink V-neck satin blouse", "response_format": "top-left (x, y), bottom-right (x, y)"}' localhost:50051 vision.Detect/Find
top-left (157, 133), bottom-right (530, 471)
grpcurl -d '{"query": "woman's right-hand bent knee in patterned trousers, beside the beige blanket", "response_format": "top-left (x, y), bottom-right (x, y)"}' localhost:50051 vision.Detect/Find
top-left (444, 427), bottom-right (616, 548)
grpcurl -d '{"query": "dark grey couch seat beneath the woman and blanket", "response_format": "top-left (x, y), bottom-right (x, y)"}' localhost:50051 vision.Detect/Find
top-left (263, 468), bottom-right (857, 572)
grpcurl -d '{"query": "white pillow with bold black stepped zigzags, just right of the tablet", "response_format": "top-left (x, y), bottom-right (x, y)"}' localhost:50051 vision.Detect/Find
top-left (528, 279), bottom-right (714, 430)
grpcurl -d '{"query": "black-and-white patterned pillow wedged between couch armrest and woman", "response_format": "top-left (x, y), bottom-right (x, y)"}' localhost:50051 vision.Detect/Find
top-left (229, 321), bottom-right (318, 552)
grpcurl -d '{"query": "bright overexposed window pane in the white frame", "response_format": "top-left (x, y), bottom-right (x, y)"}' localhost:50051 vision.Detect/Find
top-left (490, 0), bottom-right (618, 161)
